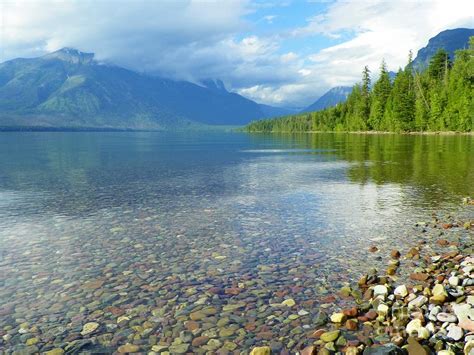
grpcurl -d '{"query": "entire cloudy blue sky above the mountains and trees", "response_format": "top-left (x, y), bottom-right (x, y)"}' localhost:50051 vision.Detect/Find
top-left (0, 0), bottom-right (474, 107)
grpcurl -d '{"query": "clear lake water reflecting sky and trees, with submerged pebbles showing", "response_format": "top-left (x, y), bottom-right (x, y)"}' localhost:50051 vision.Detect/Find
top-left (0, 132), bottom-right (474, 353)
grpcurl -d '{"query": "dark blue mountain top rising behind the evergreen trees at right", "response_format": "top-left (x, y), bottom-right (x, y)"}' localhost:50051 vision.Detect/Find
top-left (413, 28), bottom-right (474, 70)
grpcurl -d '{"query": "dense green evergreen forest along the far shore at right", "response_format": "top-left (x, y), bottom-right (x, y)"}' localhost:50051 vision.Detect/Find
top-left (246, 37), bottom-right (474, 132)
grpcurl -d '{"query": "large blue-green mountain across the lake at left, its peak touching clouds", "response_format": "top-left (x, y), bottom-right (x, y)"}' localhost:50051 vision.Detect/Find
top-left (0, 48), bottom-right (282, 129)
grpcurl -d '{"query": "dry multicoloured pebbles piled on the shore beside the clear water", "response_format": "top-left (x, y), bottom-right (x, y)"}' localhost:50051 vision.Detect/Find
top-left (251, 209), bottom-right (474, 355)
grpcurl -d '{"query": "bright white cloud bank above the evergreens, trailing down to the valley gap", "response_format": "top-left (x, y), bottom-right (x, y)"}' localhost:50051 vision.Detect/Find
top-left (241, 0), bottom-right (474, 105)
